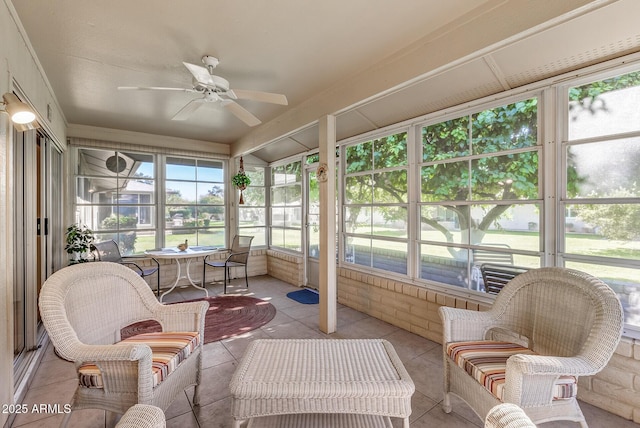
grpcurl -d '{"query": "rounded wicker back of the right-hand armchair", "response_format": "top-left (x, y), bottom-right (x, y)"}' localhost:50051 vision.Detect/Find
top-left (491, 267), bottom-right (624, 368)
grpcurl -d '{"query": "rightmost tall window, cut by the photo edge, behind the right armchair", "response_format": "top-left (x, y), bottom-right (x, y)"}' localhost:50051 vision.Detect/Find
top-left (560, 71), bottom-right (640, 333)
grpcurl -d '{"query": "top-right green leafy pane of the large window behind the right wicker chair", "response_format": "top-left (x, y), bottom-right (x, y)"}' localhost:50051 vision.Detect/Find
top-left (471, 98), bottom-right (538, 154)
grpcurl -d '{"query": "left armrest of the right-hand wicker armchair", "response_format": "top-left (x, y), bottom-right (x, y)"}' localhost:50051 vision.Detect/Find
top-left (439, 306), bottom-right (497, 343)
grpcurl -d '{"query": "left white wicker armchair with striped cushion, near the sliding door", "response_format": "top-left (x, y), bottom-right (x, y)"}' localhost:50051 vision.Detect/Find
top-left (39, 262), bottom-right (209, 426)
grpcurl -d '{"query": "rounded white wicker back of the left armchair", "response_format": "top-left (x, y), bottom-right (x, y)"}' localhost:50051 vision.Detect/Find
top-left (39, 262), bottom-right (162, 358)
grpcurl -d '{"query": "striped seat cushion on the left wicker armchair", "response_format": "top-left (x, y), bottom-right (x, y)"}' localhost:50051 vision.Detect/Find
top-left (78, 331), bottom-right (200, 388)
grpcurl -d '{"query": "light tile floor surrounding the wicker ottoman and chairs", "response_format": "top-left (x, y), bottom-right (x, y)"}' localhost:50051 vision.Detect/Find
top-left (12, 276), bottom-right (638, 428)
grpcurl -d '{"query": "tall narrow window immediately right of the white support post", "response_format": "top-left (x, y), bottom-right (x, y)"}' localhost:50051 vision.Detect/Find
top-left (343, 132), bottom-right (409, 275)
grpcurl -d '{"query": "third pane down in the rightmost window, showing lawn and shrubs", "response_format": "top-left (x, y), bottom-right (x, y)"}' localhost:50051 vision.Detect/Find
top-left (565, 204), bottom-right (640, 260)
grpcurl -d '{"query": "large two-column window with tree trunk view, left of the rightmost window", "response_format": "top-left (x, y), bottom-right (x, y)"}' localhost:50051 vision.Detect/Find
top-left (419, 98), bottom-right (542, 291)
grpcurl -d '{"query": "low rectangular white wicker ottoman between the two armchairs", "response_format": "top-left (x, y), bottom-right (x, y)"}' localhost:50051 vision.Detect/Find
top-left (229, 339), bottom-right (415, 428)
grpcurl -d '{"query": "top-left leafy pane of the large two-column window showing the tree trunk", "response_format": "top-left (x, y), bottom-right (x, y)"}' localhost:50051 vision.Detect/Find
top-left (422, 116), bottom-right (469, 162)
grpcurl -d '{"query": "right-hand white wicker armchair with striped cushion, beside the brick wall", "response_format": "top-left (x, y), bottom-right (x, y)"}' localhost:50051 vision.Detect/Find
top-left (440, 268), bottom-right (623, 428)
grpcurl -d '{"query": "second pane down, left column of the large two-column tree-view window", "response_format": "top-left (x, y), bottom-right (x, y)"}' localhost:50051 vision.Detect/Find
top-left (421, 161), bottom-right (469, 202)
